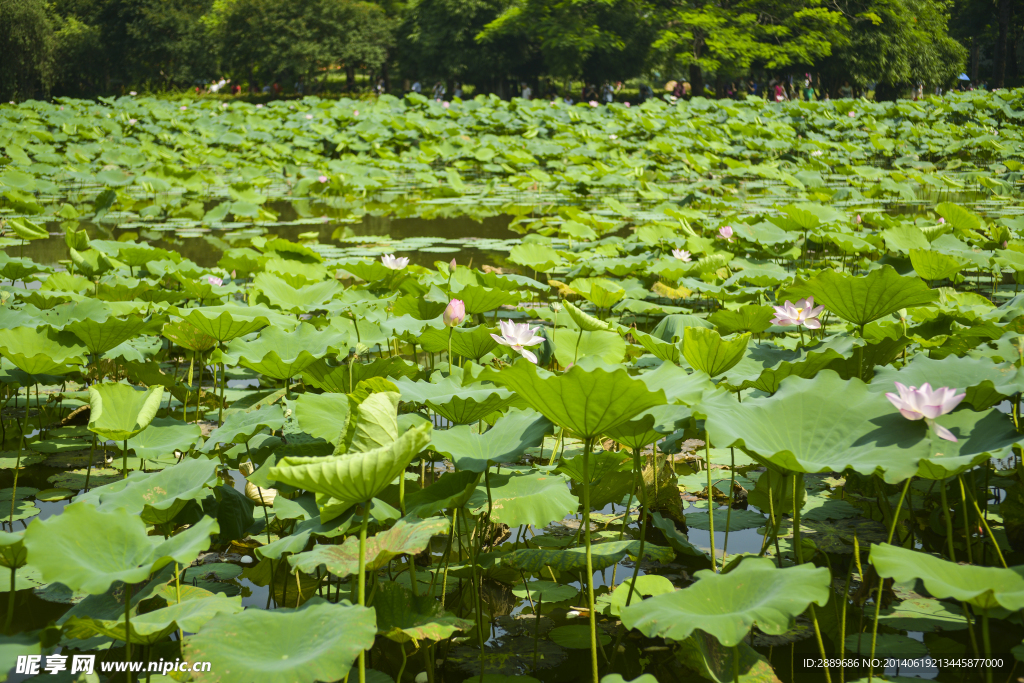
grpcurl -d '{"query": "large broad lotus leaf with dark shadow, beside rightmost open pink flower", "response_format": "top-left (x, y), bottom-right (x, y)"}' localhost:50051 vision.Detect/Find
top-left (707, 371), bottom-right (933, 482)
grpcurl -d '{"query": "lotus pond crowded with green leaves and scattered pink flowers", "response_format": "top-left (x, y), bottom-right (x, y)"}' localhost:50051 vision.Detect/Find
top-left (0, 91), bottom-right (1024, 683)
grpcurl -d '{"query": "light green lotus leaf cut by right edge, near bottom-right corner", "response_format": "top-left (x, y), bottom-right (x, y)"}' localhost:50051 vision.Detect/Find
top-left (868, 543), bottom-right (1024, 611)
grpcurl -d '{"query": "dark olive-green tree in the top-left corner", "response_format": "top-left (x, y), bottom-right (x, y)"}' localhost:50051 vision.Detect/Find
top-left (0, 0), bottom-right (53, 101)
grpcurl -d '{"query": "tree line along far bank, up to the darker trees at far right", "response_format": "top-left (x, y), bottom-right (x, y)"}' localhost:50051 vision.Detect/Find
top-left (0, 0), bottom-right (974, 100)
